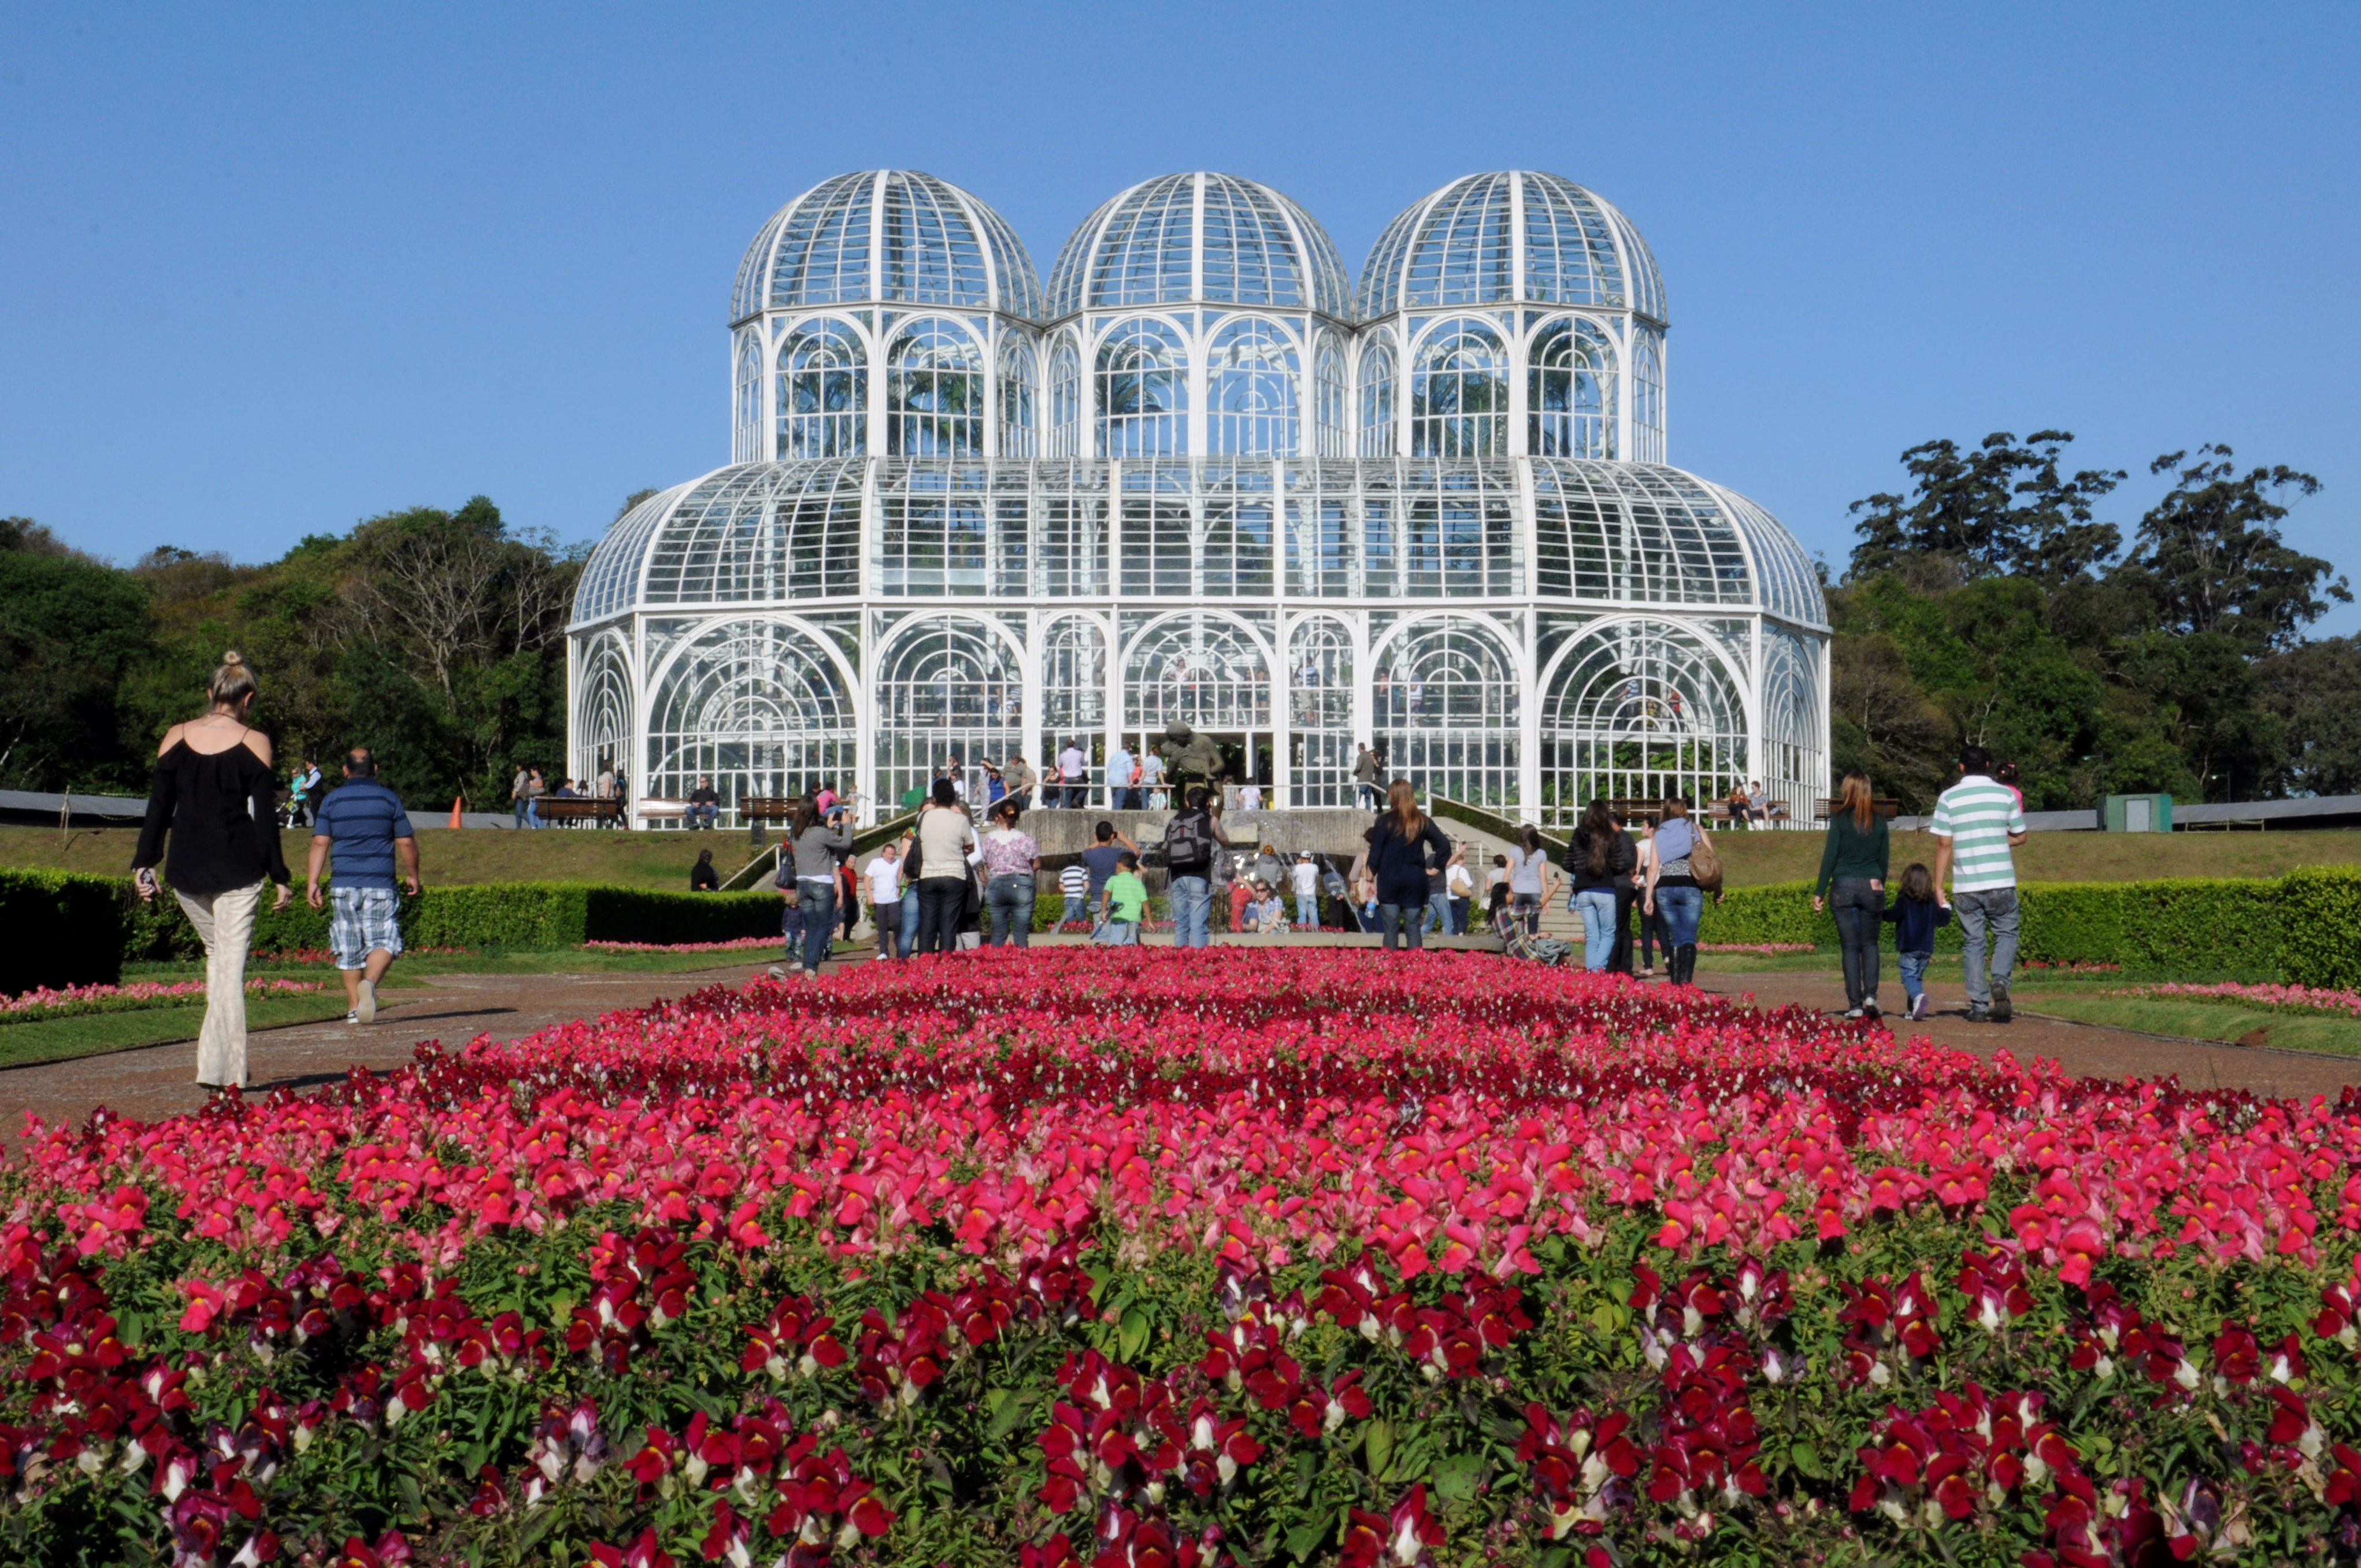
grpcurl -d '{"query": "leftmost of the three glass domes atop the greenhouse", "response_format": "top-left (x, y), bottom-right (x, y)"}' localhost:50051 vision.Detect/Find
top-left (729, 168), bottom-right (1041, 324)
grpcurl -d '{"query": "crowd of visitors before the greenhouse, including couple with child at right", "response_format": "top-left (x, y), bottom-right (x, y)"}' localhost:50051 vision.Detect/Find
top-left (713, 746), bottom-right (2026, 1022)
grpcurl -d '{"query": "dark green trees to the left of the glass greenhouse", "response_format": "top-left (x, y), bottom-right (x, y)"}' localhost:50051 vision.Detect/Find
top-left (0, 496), bottom-right (588, 810)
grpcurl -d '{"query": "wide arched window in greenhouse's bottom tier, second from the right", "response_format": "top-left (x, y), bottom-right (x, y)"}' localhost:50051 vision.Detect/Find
top-left (1542, 621), bottom-right (1747, 826)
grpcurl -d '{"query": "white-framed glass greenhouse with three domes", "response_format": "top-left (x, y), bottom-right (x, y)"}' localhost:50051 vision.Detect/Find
top-left (569, 170), bottom-right (1828, 826)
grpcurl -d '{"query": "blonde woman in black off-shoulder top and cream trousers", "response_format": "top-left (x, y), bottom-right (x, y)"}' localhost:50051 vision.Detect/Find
top-left (132, 652), bottom-right (293, 1089)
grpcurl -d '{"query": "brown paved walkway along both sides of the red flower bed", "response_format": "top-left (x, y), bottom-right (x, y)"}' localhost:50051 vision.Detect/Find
top-left (0, 952), bottom-right (2361, 1138)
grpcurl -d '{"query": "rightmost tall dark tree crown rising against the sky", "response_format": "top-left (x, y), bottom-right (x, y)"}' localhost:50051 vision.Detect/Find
top-left (2125, 446), bottom-right (2354, 657)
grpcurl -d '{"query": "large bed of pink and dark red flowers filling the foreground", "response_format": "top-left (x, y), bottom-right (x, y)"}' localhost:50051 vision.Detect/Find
top-left (0, 950), bottom-right (2361, 1568)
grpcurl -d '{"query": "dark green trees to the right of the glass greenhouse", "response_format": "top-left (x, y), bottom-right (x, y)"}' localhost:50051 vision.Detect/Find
top-left (1828, 430), bottom-right (2361, 810)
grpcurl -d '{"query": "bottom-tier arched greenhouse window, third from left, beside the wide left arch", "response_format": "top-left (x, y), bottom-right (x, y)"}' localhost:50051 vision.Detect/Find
top-left (876, 614), bottom-right (1025, 800)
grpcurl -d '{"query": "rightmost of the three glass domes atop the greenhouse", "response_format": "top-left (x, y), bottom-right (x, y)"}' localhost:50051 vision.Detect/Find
top-left (1360, 170), bottom-right (1665, 321)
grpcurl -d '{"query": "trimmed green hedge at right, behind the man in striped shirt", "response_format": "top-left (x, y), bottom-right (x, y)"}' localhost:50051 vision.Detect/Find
top-left (1697, 869), bottom-right (2323, 985)
